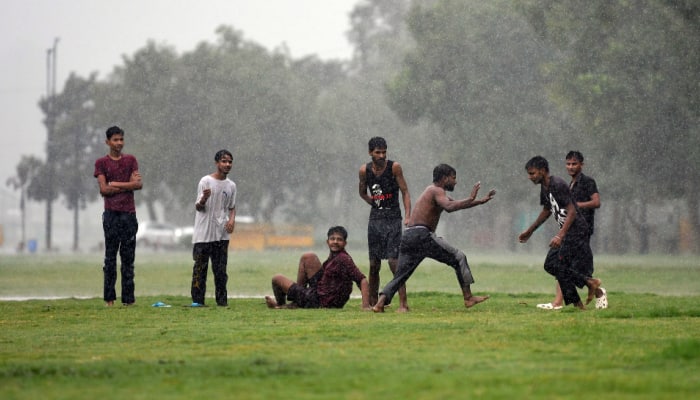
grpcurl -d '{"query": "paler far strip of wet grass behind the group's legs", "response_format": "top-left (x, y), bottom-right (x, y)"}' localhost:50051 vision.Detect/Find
top-left (0, 250), bottom-right (700, 302)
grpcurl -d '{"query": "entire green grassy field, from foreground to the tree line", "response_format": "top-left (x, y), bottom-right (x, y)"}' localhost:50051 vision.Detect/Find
top-left (0, 252), bottom-right (700, 399)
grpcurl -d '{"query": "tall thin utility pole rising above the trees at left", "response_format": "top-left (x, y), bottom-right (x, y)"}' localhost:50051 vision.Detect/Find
top-left (46, 38), bottom-right (58, 251)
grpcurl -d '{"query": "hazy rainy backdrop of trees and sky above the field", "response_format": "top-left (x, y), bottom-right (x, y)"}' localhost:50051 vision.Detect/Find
top-left (0, 0), bottom-right (700, 254)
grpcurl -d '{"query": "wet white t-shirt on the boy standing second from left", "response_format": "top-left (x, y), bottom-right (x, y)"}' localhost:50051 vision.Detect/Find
top-left (192, 175), bottom-right (236, 243)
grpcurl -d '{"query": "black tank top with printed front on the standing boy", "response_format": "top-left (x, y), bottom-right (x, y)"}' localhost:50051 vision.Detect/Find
top-left (365, 160), bottom-right (401, 219)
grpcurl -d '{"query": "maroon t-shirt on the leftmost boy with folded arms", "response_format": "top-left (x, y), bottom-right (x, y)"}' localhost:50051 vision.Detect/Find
top-left (94, 154), bottom-right (139, 213)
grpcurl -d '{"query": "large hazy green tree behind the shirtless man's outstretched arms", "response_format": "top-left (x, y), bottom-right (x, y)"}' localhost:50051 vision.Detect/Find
top-left (387, 0), bottom-right (575, 242)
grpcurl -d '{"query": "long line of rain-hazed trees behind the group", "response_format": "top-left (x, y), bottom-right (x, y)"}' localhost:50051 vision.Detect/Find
top-left (8, 0), bottom-right (700, 252)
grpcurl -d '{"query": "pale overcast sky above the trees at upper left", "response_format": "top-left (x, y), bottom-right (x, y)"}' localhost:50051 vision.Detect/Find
top-left (0, 0), bottom-right (361, 197)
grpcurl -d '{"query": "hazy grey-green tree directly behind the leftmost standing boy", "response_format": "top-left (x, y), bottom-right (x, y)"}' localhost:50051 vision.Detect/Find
top-left (97, 42), bottom-right (180, 220)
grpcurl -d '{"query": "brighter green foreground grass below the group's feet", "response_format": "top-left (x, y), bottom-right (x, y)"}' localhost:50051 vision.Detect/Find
top-left (0, 292), bottom-right (700, 399)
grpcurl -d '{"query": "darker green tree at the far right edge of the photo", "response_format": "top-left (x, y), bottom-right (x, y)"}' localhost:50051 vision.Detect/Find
top-left (523, 0), bottom-right (700, 252)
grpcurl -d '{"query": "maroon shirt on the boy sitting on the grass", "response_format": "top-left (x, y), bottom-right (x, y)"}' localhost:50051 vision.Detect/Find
top-left (316, 250), bottom-right (365, 308)
